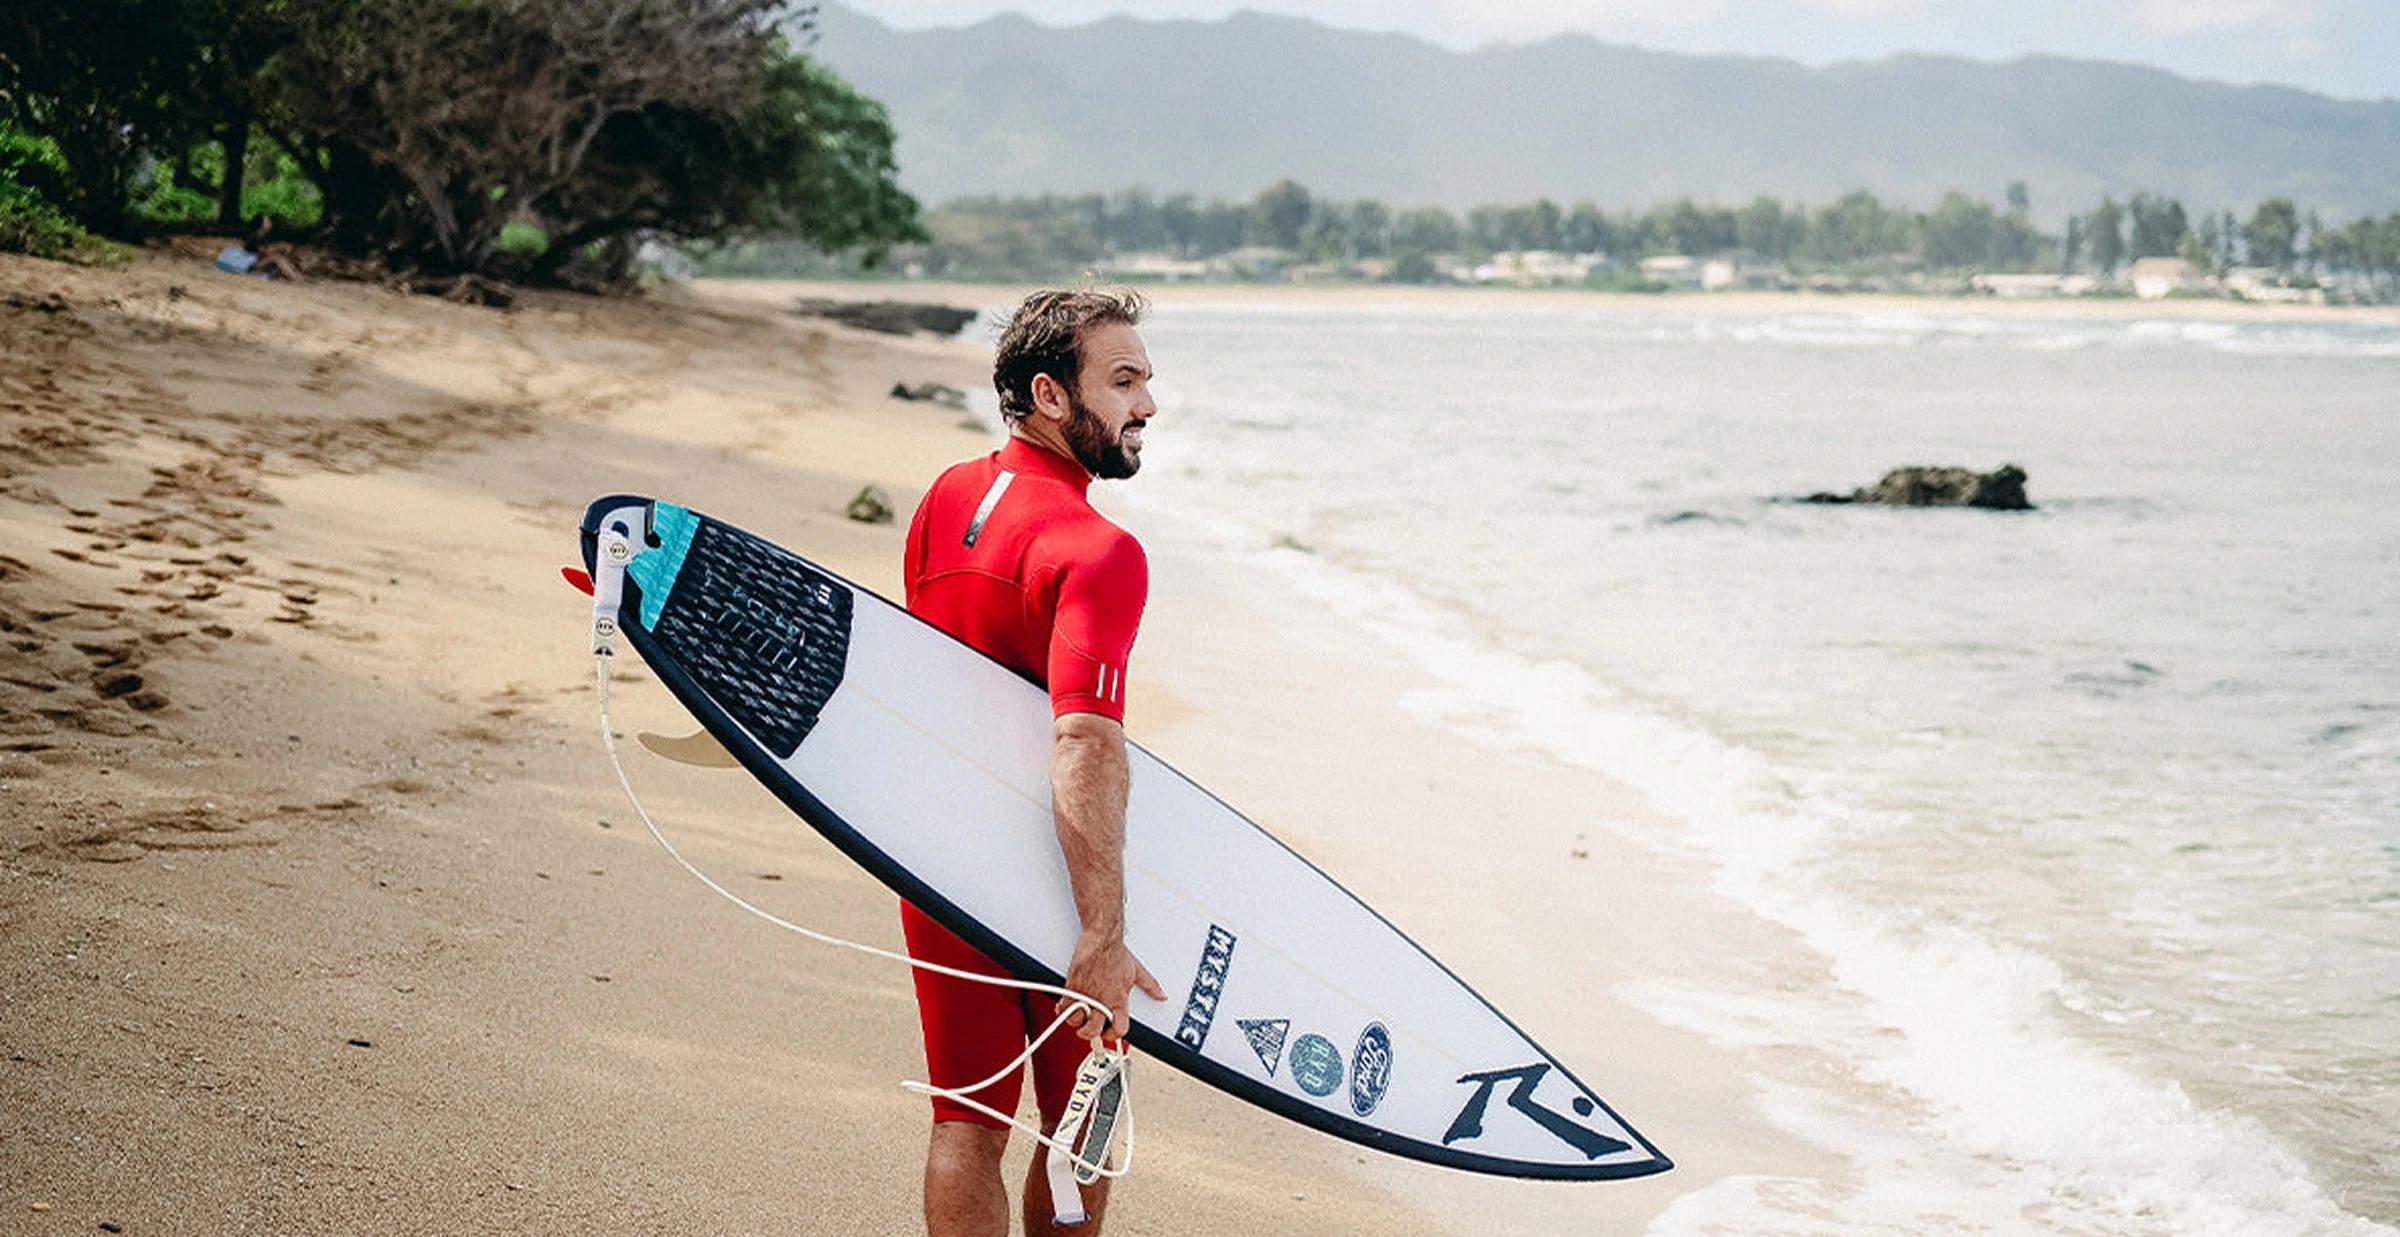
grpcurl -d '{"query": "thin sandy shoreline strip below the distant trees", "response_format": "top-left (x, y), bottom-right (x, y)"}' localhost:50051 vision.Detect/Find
top-left (689, 279), bottom-right (2400, 324)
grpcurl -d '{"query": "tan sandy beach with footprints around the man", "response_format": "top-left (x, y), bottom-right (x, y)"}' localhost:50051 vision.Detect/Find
top-left (0, 255), bottom-right (1838, 1235)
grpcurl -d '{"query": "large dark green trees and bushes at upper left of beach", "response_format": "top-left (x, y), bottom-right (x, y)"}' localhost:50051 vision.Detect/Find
top-left (0, 0), bottom-right (926, 283)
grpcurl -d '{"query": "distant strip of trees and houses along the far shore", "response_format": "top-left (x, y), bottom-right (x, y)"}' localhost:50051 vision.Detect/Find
top-left (703, 180), bottom-right (2400, 300)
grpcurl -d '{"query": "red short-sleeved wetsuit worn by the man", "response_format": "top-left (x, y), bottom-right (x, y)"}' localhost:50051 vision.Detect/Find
top-left (900, 437), bottom-right (1150, 1129)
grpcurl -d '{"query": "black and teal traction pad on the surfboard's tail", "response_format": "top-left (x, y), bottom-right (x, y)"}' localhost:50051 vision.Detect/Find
top-left (593, 500), bottom-right (854, 759)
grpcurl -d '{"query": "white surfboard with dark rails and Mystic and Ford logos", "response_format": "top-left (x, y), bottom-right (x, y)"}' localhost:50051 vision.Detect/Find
top-left (581, 495), bottom-right (1673, 1179)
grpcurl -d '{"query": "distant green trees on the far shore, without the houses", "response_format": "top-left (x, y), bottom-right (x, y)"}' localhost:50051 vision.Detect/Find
top-left (782, 183), bottom-right (2400, 295)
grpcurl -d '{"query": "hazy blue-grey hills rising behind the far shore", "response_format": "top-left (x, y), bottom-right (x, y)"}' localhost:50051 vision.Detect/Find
top-left (814, 2), bottom-right (2400, 226)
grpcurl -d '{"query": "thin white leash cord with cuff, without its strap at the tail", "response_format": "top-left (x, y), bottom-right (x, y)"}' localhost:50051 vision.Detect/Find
top-left (593, 653), bottom-right (1133, 1191)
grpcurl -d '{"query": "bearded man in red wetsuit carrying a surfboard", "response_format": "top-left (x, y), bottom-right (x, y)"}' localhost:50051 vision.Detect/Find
top-left (900, 291), bottom-right (1166, 1237)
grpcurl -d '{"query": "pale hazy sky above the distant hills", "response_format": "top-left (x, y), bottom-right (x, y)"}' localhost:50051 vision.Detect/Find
top-left (845, 0), bottom-right (2400, 98)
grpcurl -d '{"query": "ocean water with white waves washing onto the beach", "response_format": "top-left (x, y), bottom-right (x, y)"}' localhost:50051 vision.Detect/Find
top-left (1080, 295), bottom-right (2400, 1237)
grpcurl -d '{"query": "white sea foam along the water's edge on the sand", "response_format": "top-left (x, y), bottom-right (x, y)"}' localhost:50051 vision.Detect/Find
top-left (1255, 548), bottom-right (2395, 1237)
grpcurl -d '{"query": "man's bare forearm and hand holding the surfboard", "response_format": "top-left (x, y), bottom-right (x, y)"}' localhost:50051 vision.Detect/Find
top-left (1051, 713), bottom-right (1166, 1040)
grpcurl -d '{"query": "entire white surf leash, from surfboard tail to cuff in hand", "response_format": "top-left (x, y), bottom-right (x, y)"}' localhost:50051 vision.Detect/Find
top-left (585, 540), bottom-right (1133, 1225)
